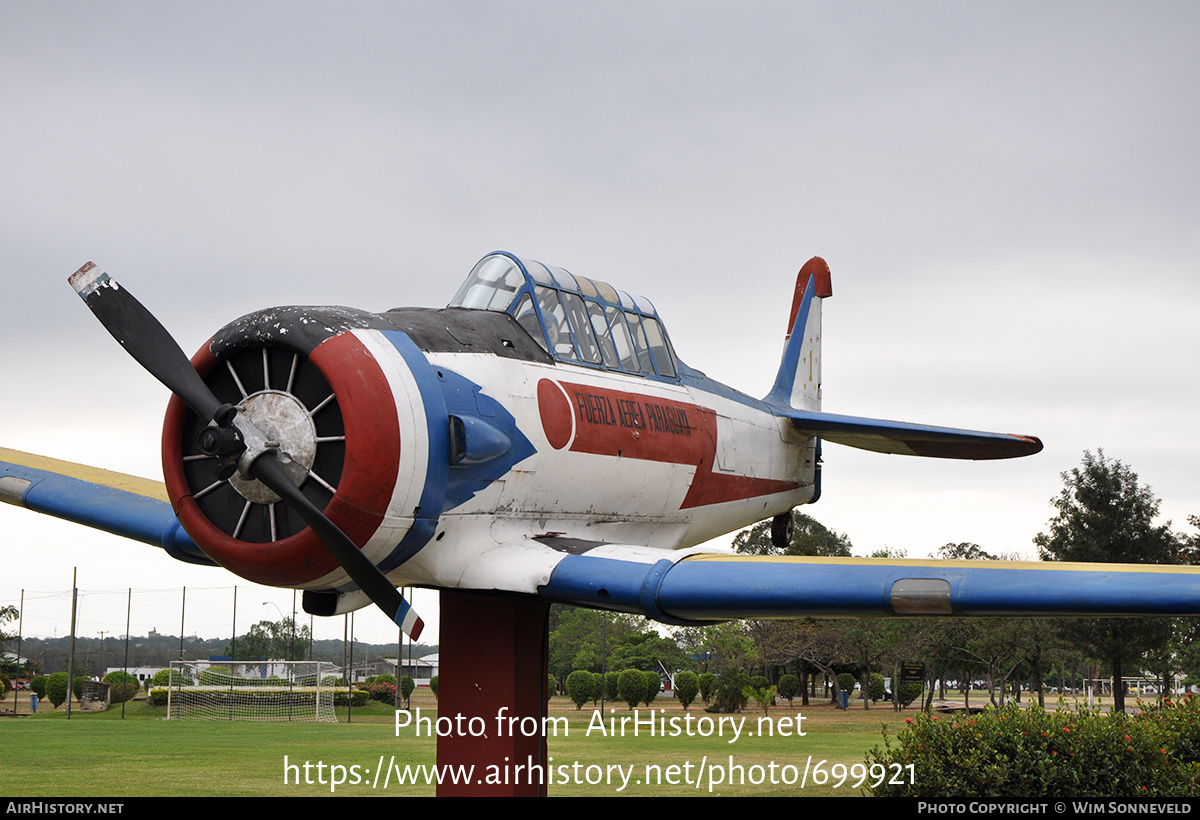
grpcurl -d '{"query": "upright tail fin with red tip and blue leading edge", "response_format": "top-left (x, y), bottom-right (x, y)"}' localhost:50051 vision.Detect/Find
top-left (766, 256), bottom-right (833, 411)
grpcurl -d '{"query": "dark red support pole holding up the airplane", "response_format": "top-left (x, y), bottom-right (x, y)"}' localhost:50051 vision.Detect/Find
top-left (438, 589), bottom-right (550, 797)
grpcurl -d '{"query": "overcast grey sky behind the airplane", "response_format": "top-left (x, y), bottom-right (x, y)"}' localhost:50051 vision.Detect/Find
top-left (0, 0), bottom-right (1200, 641)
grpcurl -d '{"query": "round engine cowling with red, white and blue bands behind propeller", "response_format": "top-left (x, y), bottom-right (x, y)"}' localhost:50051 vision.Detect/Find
top-left (162, 307), bottom-right (448, 589)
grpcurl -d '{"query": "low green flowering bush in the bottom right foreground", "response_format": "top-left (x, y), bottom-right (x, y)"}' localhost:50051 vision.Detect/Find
top-left (866, 698), bottom-right (1200, 797)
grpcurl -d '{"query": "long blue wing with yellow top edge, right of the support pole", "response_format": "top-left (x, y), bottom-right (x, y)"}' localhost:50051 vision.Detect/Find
top-left (540, 546), bottom-right (1200, 623)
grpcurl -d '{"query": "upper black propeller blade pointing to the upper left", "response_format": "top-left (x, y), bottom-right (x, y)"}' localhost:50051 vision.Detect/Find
top-left (67, 262), bottom-right (221, 420)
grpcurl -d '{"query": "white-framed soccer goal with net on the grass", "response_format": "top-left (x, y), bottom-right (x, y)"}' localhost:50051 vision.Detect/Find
top-left (159, 660), bottom-right (337, 723)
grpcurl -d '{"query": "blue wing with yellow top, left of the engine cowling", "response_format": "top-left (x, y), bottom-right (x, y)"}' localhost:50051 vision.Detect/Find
top-left (0, 448), bottom-right (216, 567)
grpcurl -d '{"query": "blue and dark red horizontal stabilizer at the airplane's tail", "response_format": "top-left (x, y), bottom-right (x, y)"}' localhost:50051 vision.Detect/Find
top-left (787, 409), bottom-right (1042, 461)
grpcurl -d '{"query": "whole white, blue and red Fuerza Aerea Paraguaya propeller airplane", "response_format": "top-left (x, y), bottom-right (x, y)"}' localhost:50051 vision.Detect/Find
top-left (0, 251), bottom-right (1200, 797)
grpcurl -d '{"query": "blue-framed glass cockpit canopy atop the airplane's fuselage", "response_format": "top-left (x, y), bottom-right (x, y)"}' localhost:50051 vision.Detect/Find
top-left (450, 251), bottom-right (678, 379)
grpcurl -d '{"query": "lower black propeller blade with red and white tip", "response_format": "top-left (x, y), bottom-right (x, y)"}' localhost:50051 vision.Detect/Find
top-left (250, 453), bottom-right (425, 641)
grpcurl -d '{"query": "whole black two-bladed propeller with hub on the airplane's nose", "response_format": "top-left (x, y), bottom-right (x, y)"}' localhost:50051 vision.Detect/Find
top-left (67, 262), bottom-right (425, 640)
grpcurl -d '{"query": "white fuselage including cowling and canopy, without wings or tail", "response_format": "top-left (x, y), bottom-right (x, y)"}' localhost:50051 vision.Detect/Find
top-left (163, 248), bottom-right (818, 592)
